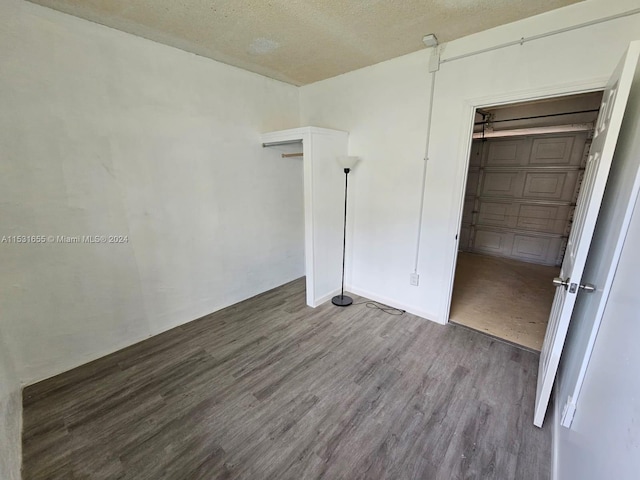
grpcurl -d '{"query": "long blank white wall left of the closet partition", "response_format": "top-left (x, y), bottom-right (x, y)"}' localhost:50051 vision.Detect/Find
top-left (0, 0), bottom-right (304, 383)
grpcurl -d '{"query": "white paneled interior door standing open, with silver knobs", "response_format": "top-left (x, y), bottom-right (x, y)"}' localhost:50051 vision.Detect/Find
top-left (533, 44), bottom-right (638, 427)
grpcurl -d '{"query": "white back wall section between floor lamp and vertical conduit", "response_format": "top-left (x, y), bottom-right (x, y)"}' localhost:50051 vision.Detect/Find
top-left (300, 52), bottom-right (435, 318)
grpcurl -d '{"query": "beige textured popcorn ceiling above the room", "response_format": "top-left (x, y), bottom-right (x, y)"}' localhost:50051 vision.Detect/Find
top-left (27, 0), bottom-right (580, 85)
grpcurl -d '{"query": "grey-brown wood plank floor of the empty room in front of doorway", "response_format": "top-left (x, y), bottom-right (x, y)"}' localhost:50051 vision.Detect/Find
top-left (23, 280), bottom-right (551, 480)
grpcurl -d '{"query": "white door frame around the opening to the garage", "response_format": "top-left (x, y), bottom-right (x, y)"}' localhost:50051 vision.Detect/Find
top-left (440, 77), bottom-right (609, 324)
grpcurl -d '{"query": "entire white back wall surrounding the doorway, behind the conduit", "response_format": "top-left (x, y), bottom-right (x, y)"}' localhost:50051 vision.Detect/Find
top-left (300, 0), bottom-right (640, 323)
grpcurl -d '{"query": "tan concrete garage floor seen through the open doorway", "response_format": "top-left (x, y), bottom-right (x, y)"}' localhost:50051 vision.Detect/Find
top-left (450, 252), bottom-right (560, 351)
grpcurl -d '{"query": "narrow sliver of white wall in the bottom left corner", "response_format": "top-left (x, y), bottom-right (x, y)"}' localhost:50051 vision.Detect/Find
top-left (0, 331), bottom-right (22, 480)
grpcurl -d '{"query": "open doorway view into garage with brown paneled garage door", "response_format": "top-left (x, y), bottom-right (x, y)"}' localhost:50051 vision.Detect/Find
top-left (449, 92), bottom-right (602, 351)
